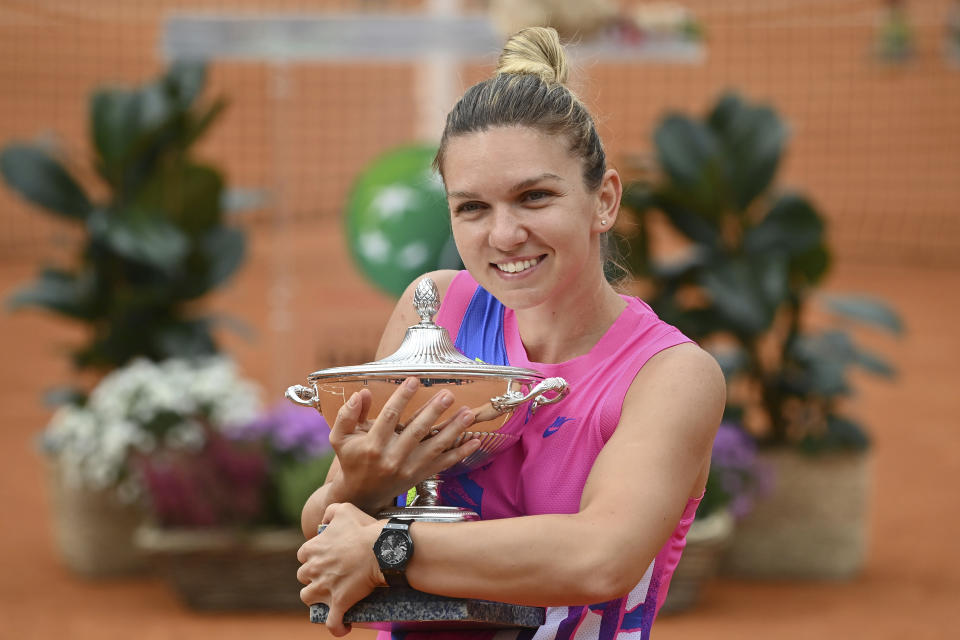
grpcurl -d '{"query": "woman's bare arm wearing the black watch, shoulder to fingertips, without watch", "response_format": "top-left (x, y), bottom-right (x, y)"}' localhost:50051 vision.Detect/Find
top-left (299, 345), bottom-right (725, 633)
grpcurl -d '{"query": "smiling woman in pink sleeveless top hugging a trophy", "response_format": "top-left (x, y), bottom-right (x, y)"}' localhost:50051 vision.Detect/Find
top-left (298, 28), bottom-right (724, 640)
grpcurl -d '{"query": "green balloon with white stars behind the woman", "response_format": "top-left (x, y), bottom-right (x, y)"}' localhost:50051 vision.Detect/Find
top-left (346, 146), bottom-right (463, 297)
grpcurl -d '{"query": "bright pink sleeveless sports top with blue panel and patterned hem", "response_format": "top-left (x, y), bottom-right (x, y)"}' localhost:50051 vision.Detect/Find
top-left (378, 271), bottom-right (700, 640)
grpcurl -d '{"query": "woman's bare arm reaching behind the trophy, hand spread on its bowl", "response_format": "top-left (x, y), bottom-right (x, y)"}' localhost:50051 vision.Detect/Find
top-left (301, 271), bottom-right (477, 538)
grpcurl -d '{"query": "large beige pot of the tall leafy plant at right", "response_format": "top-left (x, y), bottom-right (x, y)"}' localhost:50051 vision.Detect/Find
top-left (721, 450), bottom-right (871, 579)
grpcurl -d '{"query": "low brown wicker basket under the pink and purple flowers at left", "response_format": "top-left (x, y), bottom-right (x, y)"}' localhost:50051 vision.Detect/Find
top-left (136, 525), bottom-right (305, 611)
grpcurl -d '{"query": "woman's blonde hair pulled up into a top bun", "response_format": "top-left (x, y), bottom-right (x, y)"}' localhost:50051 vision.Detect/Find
top-left (434, 27), bottom-right (607, 191)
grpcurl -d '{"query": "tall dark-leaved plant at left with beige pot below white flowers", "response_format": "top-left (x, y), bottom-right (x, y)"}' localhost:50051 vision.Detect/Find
top-left (0, 63), bottom-right (245, 575)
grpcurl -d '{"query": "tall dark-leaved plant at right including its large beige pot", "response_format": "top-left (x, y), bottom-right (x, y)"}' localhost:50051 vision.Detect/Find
top-left (617, 93), bottom-right (902, 576)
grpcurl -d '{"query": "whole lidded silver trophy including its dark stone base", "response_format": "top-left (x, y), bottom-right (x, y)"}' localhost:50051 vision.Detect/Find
top-left (286, 278), bottom-right (570, 629)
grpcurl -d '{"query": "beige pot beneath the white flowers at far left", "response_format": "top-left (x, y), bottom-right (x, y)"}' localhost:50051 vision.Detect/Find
top-left (47, 459), bottom-right (148, 578)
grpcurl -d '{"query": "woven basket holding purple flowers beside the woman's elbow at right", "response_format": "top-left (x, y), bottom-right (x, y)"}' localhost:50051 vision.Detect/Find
top-left (660, 509), bottom-right (734, 614)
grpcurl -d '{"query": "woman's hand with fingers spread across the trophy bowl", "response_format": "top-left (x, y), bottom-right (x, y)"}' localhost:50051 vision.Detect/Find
top-left (330, 378), bottom-right (480, 512)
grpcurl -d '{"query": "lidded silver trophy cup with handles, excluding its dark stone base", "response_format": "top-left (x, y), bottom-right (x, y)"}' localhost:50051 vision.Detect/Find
top-left (286, 278), bottom-right (569, 520)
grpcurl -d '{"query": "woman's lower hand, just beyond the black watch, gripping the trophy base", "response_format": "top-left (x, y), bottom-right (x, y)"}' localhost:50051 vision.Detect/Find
top-left (297, 503), bottom-right (386, 636)
